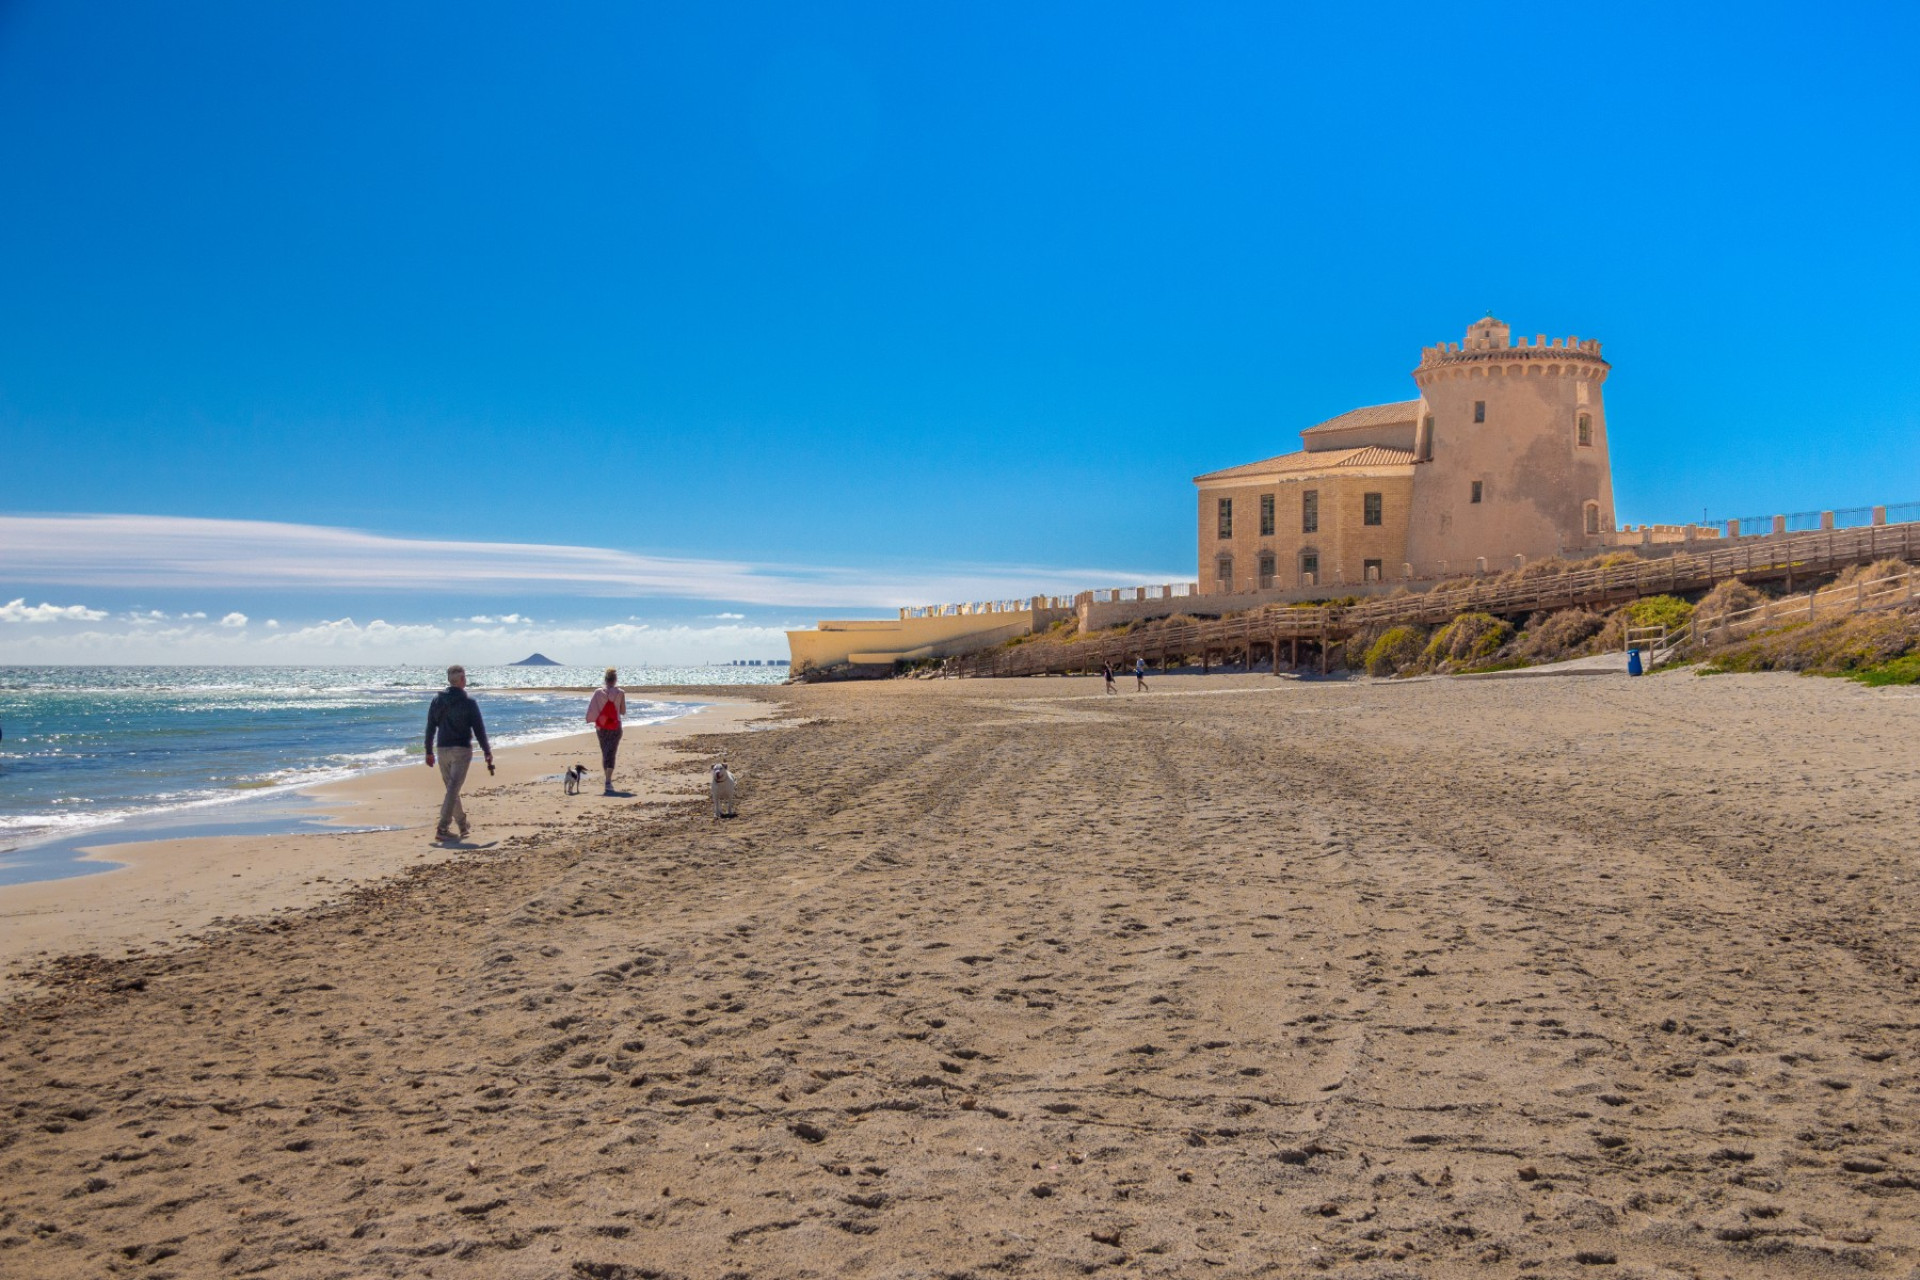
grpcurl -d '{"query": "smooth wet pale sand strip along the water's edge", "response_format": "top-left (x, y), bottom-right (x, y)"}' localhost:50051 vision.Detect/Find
top-left (0, 689), bottom-right (770, 1004)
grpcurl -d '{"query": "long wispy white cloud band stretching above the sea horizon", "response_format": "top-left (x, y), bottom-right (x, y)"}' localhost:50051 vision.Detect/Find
top-left (0, 514), bottom-right (1169, 608)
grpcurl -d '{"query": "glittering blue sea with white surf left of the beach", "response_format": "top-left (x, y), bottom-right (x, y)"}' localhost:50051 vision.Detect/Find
top-left (0, 666), bottom-right (785, 885)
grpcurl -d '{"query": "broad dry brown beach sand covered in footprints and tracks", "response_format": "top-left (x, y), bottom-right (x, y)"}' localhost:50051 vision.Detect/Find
top-left (0, 674), bottom-right (1920, 1280)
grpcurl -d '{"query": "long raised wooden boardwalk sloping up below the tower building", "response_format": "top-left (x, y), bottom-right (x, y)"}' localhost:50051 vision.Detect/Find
top-left (947, 522), bottom-right (1920, 676)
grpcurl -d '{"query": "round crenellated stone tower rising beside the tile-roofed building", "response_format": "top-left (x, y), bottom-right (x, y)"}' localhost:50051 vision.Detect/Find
top-left (1407, 315), bottom-right (1613, 572)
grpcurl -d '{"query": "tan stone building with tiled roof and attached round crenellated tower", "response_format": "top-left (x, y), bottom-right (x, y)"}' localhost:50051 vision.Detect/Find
top-left (1194, 317), bottom-right (1613, 595)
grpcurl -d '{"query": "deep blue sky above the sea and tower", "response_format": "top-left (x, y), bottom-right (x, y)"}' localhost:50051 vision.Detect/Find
top-left (0, 0), bottom-right (1920, 658)
